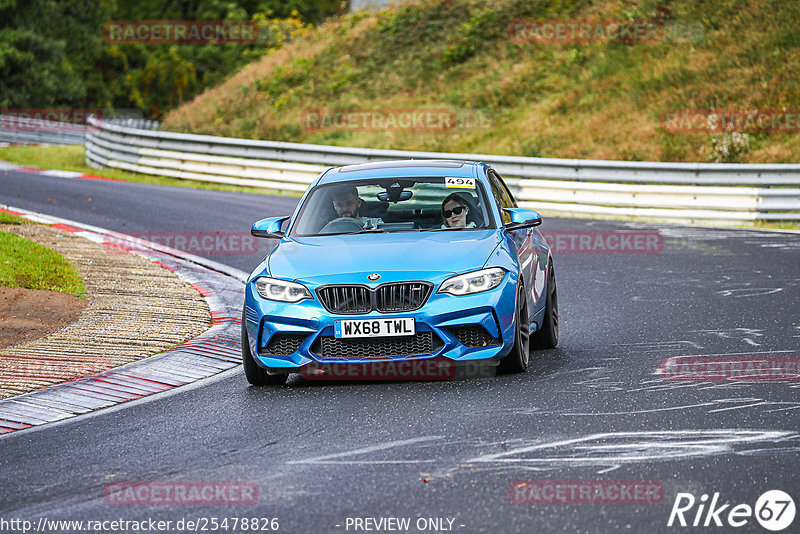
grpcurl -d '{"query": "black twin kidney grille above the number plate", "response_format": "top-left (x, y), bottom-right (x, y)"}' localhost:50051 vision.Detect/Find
top-left (317, 282), bottom-right (433, 314)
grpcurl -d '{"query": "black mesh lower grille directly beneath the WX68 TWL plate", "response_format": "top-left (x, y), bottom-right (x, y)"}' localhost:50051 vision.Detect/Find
top-left (317, 332), bottom-right (441, 360)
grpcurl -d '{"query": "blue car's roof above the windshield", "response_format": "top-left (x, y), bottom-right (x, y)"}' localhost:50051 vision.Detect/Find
top-left (318, 159), bottom-right (486, 184)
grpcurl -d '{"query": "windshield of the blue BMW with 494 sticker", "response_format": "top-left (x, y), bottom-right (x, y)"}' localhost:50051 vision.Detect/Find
top-left (290, 177), bottom-right (493, 236)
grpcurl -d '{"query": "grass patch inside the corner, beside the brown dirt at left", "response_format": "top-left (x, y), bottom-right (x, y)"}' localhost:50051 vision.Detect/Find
top-left (0, 230), bottom-right (86, 297)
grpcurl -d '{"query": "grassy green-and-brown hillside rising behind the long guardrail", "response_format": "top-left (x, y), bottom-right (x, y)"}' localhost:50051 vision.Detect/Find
top-left (163, 0), bottom-right (800, 162)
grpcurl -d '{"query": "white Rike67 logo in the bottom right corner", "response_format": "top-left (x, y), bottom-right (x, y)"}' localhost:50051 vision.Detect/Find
top-left (667, 490), bottom-right (796, 532)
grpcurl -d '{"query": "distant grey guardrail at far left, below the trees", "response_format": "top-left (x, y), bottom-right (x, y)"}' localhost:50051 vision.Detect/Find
top-left (0, 114), bottom-right (160, 145)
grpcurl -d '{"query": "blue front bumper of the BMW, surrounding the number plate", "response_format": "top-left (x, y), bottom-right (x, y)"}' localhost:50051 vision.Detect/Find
top-left (245, 272), bottom-right (517, 372)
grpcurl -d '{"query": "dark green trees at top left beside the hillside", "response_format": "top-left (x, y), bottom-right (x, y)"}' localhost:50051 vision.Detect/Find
top-left (0, 0), bottom-right (347, 117)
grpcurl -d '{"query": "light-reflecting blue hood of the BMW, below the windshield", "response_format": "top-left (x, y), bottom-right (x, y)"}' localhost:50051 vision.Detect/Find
top-left (268, 230), bottom-right (500, 280)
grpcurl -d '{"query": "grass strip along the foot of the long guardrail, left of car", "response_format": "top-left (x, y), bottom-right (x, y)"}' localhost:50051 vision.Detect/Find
top-left (0, 145), bottom-right (299, 196)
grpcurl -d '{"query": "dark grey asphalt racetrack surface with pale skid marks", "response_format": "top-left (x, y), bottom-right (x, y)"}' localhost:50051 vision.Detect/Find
top-left (0, 171), bottom-right (800, 532)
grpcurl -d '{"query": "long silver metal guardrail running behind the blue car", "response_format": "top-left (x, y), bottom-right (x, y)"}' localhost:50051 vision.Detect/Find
top-left (86, 118), bottom-right (800, 224)
